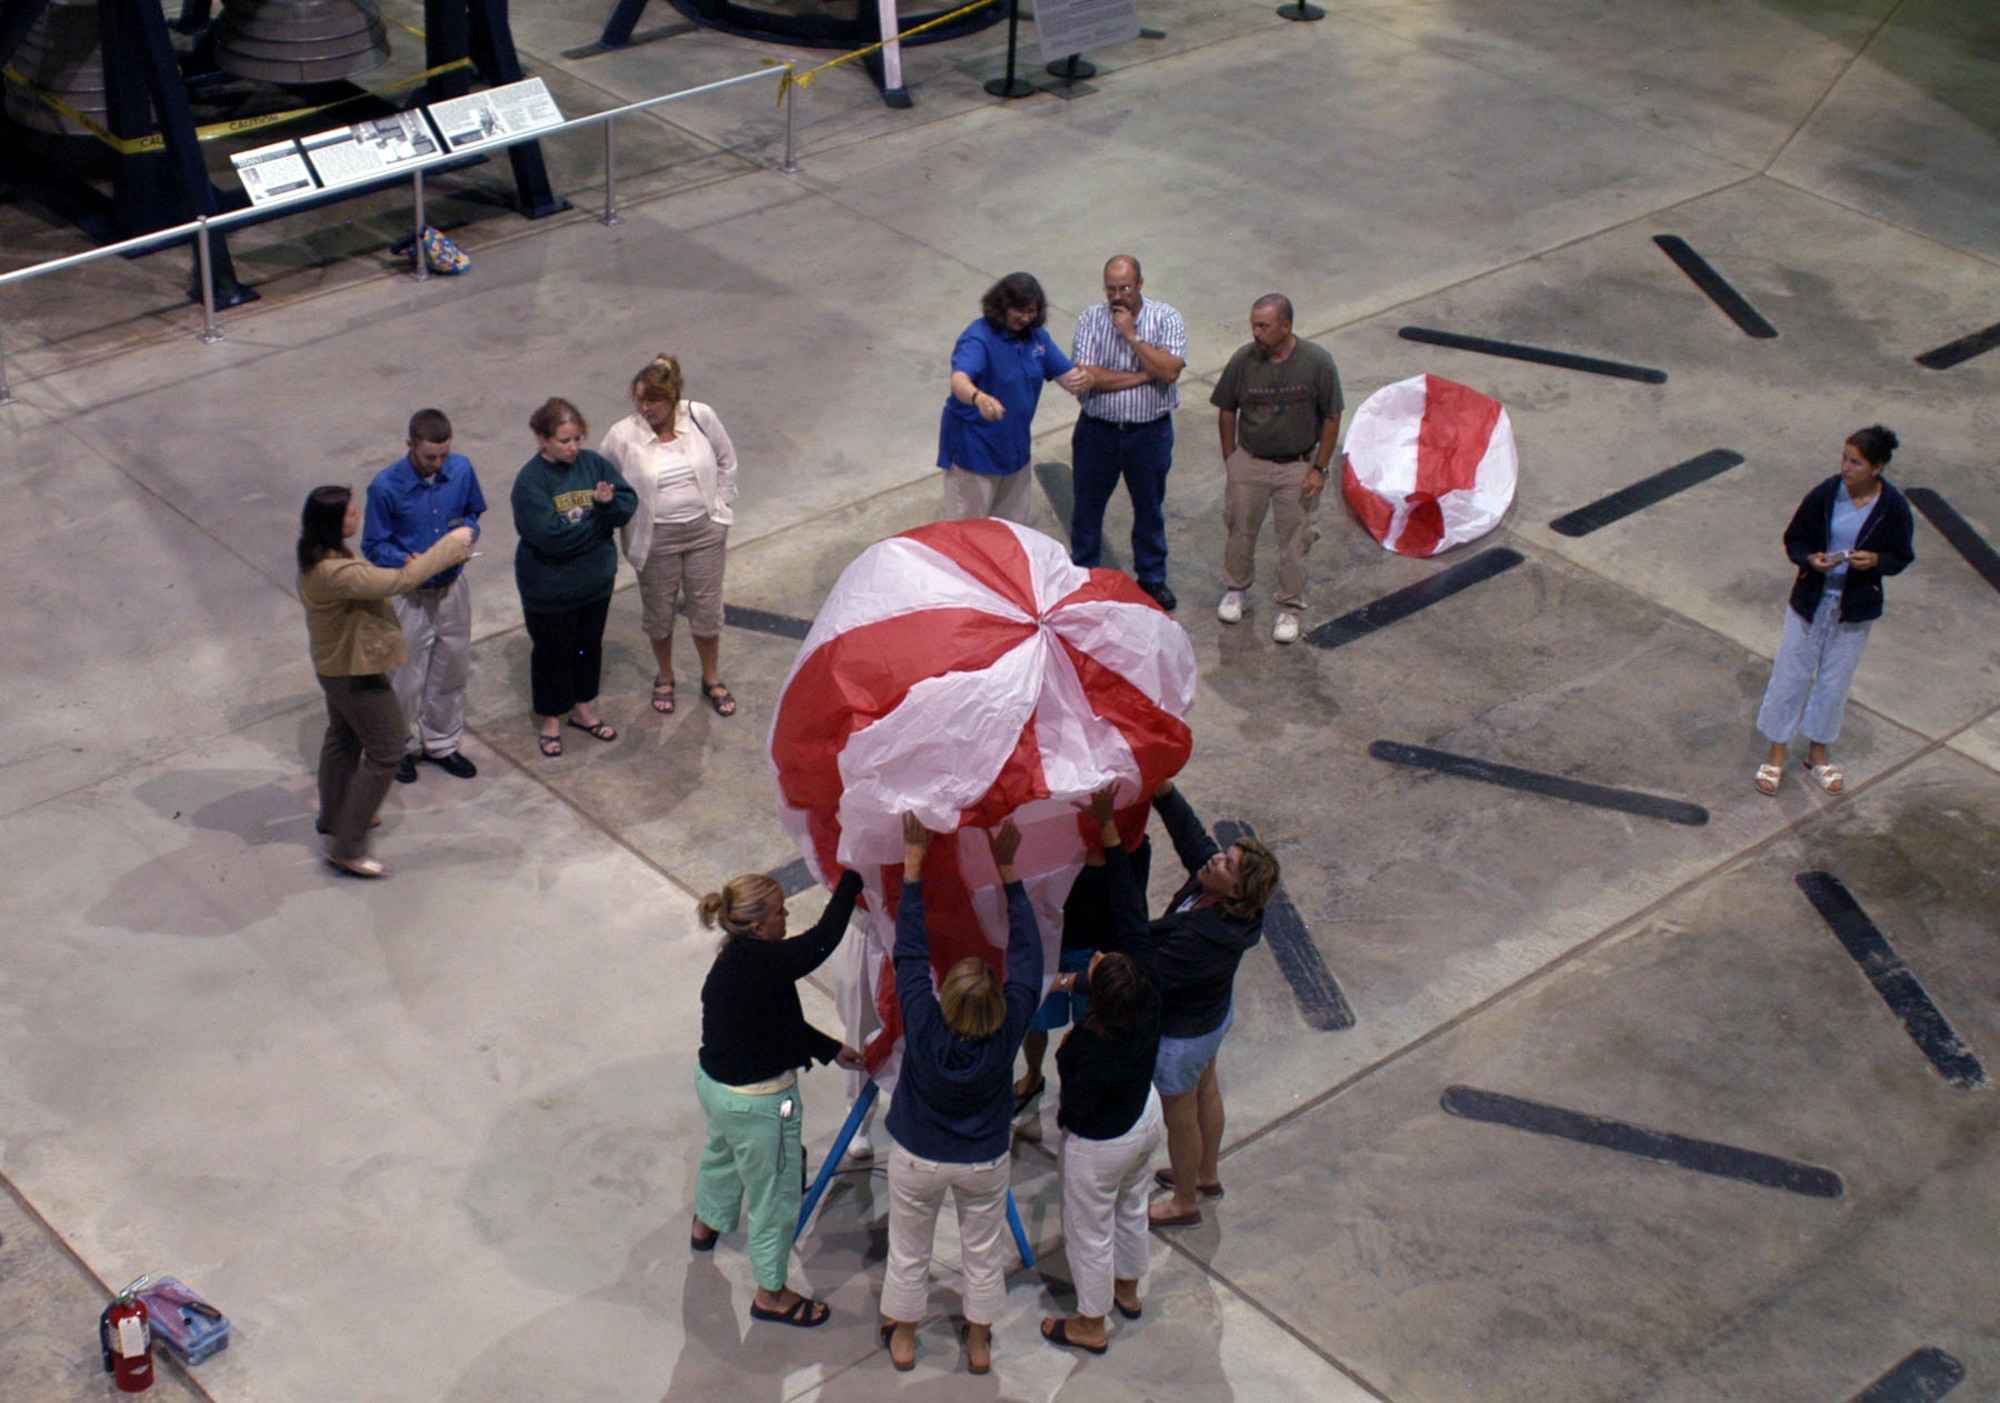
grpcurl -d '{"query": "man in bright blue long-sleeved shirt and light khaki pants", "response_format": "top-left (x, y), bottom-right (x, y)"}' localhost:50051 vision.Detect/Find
top-left (362, 410), bottom-right (486, 783)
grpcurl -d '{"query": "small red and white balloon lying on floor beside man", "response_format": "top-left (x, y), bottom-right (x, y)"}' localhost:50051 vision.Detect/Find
top-left (1340, 376), bottom-right (1520, 556)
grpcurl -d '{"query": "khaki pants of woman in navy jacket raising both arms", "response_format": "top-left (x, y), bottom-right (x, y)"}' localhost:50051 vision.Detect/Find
top-left (882, 1145), bottom-right (1014, 1325)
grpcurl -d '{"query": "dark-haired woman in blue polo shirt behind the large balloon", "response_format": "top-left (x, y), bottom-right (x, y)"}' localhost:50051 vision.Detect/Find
top-left (938, 274), bottom-right (1090, 524)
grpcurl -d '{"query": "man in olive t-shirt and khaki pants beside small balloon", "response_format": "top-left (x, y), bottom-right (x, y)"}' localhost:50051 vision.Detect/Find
top-left (1208, 292), bottom-right (1346, 644)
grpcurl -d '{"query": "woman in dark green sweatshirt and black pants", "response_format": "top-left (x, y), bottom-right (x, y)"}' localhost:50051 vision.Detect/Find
top-left (512, 400), bottom-right (638, 757)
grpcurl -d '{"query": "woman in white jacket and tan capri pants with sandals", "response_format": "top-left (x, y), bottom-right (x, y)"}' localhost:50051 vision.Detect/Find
top-left (598, 352), bottom-right (736, 715)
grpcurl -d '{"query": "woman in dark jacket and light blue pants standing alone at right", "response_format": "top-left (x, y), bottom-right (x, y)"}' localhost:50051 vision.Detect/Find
top-left (1756, 424), bottom-right (1916, 793)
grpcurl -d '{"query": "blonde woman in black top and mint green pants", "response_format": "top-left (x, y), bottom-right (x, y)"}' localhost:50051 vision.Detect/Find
top-left (690, 871), bottom-right (862, 1327)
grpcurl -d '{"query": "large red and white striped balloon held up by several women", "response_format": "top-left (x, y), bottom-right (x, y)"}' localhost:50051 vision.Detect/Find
top-left (770, 518), bottom-right (1196, 1079)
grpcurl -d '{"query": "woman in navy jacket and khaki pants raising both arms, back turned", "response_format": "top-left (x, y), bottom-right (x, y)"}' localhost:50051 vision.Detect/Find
top-left (882, 813), bottom-right (1042, 1373)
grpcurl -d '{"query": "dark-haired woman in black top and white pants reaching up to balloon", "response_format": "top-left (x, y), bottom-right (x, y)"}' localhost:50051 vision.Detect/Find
top-left (1042, 789), bottom-right (1164, 1355)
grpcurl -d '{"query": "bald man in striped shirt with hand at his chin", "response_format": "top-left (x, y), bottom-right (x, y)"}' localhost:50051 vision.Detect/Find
top-left (1070, 254), bottom-right (1188, 610)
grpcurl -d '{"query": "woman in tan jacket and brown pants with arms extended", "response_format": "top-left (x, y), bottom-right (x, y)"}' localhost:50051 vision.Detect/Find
top-left (298, 488), bottom-right (472, 877)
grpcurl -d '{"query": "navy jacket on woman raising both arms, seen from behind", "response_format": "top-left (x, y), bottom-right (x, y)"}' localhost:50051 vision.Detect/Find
top-left (888, 881), bottom-right (1042, 1165)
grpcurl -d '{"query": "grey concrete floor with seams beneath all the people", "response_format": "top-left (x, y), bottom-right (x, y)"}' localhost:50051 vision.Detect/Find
top-left (0, 0), bottom-right (2000, 1403)
